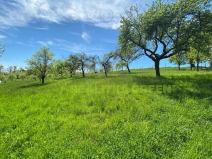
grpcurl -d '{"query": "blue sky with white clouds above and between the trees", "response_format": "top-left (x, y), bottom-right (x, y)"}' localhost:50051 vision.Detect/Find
top-left (0, 0), bottom-right (172, 68)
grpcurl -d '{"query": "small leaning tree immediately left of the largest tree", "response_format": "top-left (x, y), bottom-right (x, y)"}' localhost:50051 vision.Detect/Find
top-left (114, 46), bottom-right (141, 73)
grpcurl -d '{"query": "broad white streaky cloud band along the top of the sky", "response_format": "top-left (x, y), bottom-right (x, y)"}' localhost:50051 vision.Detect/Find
top-left (0, 0), bottom-right (151, 29)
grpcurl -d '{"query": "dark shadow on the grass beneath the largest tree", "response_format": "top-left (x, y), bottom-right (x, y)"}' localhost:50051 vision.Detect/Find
top-left (134, 74), bottom-right (212, 101)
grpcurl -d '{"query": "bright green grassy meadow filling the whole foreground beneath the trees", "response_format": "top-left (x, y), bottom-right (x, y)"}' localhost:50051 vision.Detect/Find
top-left (0, 69), bottom-right (212, 159)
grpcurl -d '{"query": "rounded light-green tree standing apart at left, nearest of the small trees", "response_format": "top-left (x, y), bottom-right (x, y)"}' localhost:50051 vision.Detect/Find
top-left (27, 47), bottom-right (53, 84)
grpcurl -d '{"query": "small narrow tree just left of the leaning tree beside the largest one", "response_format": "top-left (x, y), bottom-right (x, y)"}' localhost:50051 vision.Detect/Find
top-left (100, 52), bottom-right (114, 77)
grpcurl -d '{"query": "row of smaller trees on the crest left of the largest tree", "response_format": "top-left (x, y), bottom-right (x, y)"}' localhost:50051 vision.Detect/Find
top-left (27, 47), bottom-right (142, 83)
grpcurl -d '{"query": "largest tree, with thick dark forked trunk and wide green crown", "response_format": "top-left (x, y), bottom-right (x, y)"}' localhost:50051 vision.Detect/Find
top-left (119, 0), bottom-right (210, 76)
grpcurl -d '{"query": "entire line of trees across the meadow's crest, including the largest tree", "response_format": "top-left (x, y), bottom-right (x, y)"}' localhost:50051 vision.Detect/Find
top-left (0, 0), bottom-right (212, 83)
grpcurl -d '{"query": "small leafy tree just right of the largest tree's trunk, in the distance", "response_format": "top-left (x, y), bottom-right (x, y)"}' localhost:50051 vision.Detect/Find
top-left (169, 52), bottom-right (186, 70)
